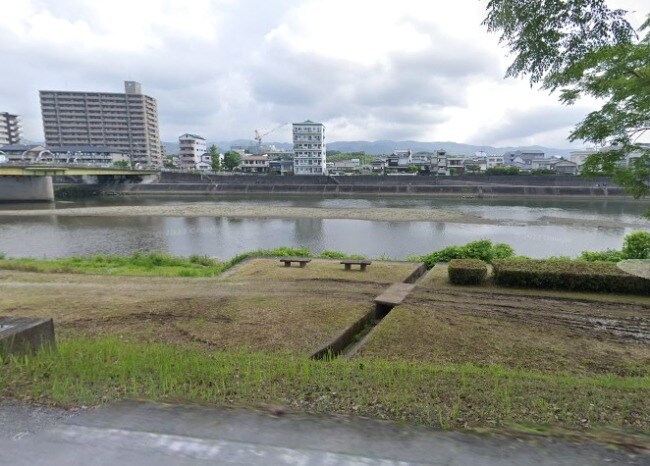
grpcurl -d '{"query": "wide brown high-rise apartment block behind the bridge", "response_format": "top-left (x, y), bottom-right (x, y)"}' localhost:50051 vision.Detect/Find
top-left (40, 81), bottom-right (162, 166)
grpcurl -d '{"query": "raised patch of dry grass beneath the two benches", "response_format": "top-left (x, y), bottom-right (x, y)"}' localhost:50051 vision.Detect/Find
top-left (224, 258), bottom-right (419, 284)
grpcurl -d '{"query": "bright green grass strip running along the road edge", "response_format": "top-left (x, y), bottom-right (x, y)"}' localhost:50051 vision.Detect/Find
top-left (0, 338), bottom-right (650, 434)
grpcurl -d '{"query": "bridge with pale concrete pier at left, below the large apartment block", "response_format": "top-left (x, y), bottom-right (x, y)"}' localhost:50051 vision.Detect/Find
top-left (0, 164), bottom-right (158, 202)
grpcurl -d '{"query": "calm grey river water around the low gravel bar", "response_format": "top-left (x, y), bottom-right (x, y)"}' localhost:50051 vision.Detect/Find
top-left (0, 196), bottom-right (650, 259)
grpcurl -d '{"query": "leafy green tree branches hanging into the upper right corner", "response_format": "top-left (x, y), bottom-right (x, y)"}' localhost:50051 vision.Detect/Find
top-left (483, 0), bottom-right (650, 206)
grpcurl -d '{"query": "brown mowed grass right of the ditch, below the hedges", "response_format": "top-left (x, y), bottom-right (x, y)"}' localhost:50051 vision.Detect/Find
top-left (356, 301), bottom-right (650, 376)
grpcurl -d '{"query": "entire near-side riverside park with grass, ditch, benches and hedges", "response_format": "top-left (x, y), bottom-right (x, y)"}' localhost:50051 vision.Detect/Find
top-left (0, 228), bottom-right (650, 460)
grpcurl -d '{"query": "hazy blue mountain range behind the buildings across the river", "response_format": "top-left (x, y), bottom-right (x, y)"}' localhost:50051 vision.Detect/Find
top-left (163, 139), bottom-right (573, 157)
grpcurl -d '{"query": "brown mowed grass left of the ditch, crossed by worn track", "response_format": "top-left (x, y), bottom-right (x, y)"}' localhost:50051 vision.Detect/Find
top-left (0, 271), bottom-right (378, 356)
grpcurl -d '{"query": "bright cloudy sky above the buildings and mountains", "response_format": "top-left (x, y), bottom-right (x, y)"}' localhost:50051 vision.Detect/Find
top-left (0, 0), bottom-right (647, 148)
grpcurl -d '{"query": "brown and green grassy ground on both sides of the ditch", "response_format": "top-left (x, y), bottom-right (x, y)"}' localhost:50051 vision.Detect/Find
top-left (0, 259), bottom-right (650, 444)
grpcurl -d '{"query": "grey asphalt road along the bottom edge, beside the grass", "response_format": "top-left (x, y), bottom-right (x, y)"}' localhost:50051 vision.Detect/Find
top-left (0, 402), bottom-right (650, 466)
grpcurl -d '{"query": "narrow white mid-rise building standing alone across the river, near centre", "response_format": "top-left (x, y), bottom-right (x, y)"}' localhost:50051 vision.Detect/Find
top-left (293, 120), bottom-right (327, 175)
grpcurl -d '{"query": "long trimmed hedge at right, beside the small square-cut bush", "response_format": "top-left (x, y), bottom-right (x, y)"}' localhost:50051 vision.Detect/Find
top-left (492, 259), bottom-right (650, 295)
